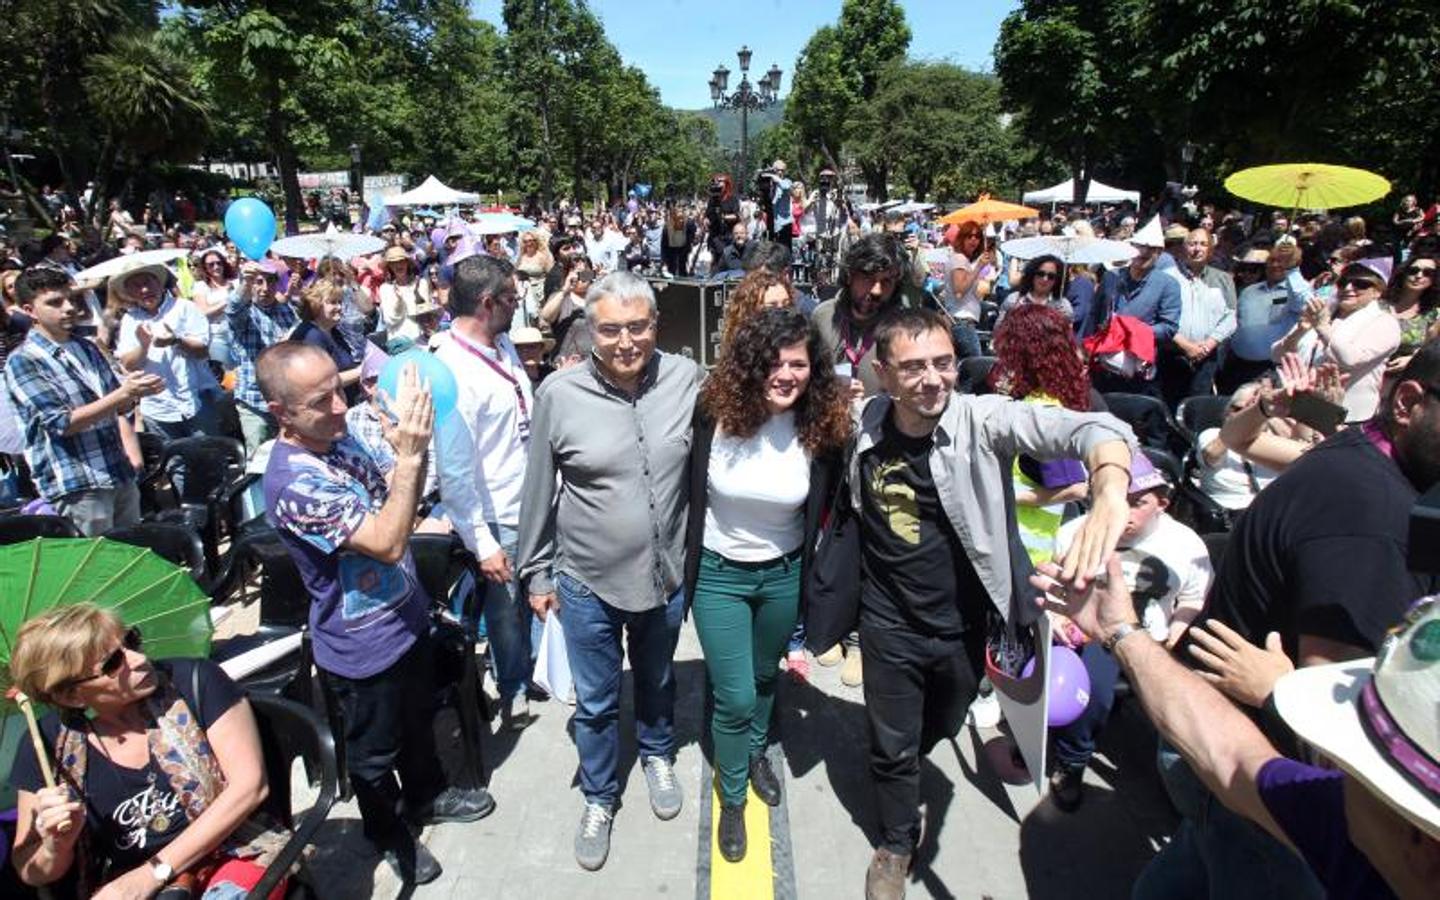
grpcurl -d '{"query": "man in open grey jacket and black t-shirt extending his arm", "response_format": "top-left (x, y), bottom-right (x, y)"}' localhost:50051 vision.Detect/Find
top-left (841, 308), bottom-right (1135, 900)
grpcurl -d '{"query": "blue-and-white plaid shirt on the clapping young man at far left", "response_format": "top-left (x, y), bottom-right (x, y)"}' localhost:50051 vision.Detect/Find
top-left (6, 328), bottom-right (135, 500)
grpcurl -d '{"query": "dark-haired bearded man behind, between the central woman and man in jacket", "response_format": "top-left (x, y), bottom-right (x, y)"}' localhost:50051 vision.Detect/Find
top-left (811, 233), bottom-right (916, 399)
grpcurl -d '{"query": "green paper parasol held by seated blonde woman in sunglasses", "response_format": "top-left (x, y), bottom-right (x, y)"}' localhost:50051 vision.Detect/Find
top-left (0, 537), bottom-right (213, 808)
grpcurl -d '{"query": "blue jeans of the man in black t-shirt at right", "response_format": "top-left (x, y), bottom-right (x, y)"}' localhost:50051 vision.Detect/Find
top-left (1130, 740), bottom-right (1325, 900)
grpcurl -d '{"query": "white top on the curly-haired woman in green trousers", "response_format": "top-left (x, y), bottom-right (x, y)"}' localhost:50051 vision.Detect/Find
top-left (703, 410), bottom-right (809, 563)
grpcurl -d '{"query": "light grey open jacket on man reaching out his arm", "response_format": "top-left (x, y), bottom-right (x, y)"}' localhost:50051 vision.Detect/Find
top-left (845, 393), bottom-right (1139, 622)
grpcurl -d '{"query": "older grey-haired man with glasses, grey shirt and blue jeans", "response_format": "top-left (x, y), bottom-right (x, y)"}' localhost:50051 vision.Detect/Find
top-left (517, 272), bottom-right (700, 870)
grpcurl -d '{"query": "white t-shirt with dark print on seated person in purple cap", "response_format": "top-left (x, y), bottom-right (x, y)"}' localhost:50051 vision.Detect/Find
top-left (1056, 513), bottom-right (1214, 641)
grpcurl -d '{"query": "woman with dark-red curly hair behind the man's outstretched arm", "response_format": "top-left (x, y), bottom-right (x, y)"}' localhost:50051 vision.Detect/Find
top-left (989, 304), bottom-right (1103, 563)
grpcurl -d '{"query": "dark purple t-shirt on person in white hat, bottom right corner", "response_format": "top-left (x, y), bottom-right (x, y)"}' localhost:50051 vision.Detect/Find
top-left (1256, 756), bottom-right (1395, 900)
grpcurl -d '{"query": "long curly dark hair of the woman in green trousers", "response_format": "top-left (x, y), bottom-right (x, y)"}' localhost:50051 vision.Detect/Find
top-left (700, 310), bottom-right (851, 456)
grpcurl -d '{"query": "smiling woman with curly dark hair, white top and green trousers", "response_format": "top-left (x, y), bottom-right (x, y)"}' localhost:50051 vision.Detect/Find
top-left (685, 310), bottom-right (851, 863)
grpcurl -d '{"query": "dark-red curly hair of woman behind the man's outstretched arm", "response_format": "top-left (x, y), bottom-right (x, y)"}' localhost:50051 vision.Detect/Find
top-left (989, 304), bottom-right (1090, 412)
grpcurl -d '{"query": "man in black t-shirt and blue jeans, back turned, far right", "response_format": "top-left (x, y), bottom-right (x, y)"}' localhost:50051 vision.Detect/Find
top-left (1135, 340), bottom-right (1440, 899)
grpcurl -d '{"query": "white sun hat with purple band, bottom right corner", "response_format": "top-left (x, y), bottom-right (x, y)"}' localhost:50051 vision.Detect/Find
top-left (1274, 595), bottom-right (1440, 840)
